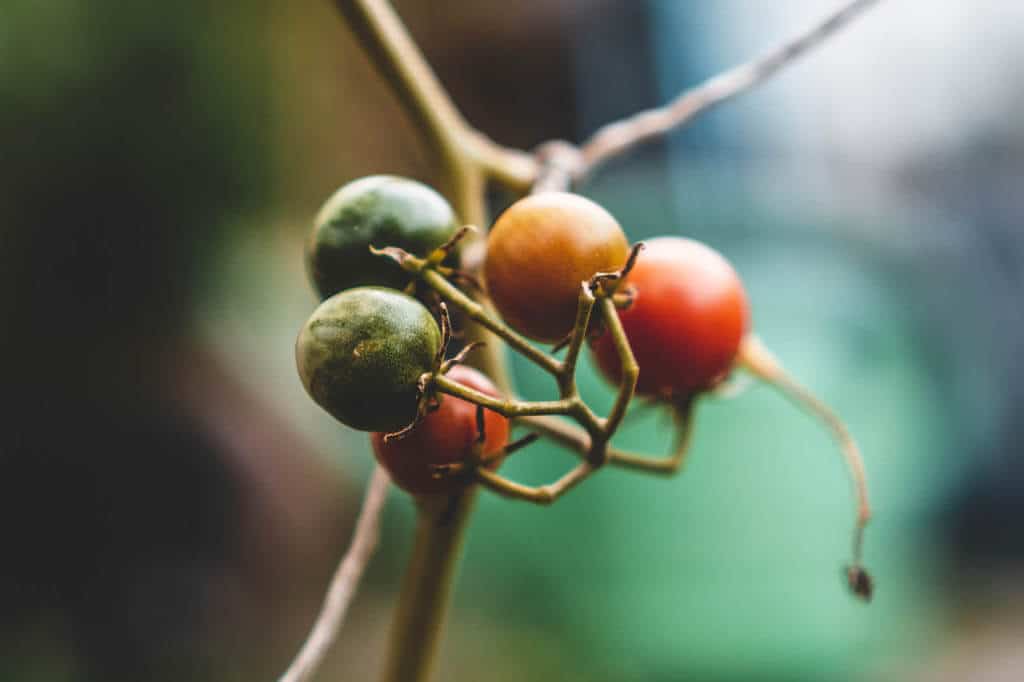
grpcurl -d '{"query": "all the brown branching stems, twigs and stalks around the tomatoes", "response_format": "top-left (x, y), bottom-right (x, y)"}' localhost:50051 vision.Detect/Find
top-left (282, 0), bottom-right (878, 682)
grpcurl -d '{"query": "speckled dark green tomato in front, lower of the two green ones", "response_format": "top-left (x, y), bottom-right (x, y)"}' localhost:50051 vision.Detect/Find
top-left (295, 287), bottom-right (441, 432)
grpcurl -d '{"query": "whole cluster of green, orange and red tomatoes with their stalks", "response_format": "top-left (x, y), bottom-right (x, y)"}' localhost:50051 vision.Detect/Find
top-left (296, 176), bottom-right (870, 596)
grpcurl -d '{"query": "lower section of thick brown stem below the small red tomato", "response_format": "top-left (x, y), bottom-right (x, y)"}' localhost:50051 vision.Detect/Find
top-left (381, 485), bottom-right (477, 682)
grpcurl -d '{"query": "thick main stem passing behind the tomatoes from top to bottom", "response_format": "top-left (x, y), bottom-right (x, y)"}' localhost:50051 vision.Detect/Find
top-left (336, 5), bottom-right (507, 682)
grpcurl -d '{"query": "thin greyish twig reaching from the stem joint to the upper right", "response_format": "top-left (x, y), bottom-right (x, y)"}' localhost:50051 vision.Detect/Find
top-left (572, 0), bottom-right (879, 182)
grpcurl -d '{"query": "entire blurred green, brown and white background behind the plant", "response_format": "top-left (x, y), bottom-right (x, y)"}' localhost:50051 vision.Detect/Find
top-left (0, 0), bottom-right (1024, 682)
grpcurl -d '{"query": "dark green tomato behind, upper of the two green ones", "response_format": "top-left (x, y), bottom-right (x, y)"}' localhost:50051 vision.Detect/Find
top-left (306, 175), bottom-right (458, 298)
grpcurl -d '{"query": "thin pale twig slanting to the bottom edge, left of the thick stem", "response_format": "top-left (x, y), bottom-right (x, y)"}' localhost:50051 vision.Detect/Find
top-left (279, 466), bottom-right (390, 682)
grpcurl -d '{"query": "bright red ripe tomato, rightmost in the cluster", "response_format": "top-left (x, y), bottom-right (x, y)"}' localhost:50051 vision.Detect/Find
top-left (592, 237), bottom-right (750, 399)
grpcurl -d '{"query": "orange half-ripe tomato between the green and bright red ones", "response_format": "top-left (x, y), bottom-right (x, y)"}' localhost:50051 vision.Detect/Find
top-left (483, 191), bottom-right (629, 342)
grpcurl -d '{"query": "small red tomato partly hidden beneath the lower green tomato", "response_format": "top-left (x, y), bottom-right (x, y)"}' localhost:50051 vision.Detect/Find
top-left (370, 365), bottom-right (509, 495)
